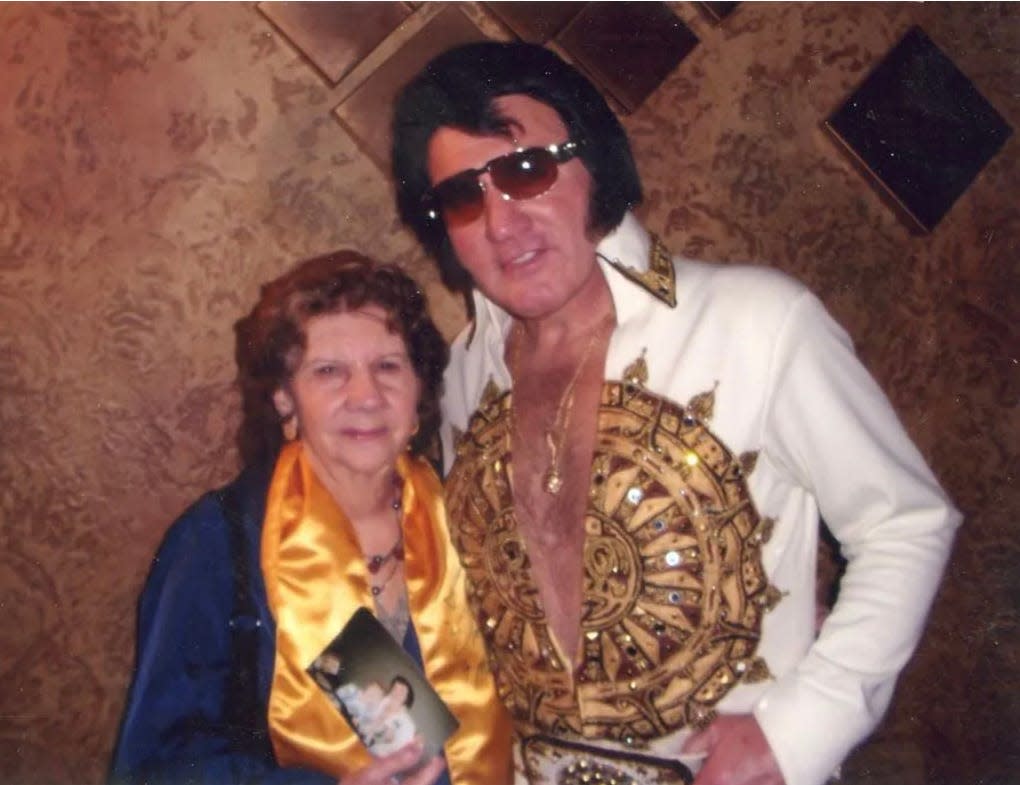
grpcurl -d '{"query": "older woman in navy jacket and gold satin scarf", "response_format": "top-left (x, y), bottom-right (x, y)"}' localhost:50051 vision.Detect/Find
top-left (111, 252), bottom-right (510, 785)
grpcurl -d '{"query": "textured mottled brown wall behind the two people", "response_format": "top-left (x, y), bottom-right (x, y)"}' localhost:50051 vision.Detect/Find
top-left (0, 3), bottom-right (1020, 785)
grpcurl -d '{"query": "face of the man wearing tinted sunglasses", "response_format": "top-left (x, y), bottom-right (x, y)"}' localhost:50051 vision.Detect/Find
top-left (427, 95), bottom-right (601, 319)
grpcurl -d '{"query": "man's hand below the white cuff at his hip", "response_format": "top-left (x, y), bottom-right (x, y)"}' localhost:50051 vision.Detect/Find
top-left (681, 714), bottom-right (785, 785)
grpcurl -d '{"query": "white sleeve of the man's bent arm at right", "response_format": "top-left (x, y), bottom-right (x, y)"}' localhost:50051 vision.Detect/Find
top-left (754, 293), bottom-right (961, 785)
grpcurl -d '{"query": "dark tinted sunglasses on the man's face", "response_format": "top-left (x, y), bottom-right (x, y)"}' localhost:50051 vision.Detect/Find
top-left (423, 140), bottom-right (580, 225)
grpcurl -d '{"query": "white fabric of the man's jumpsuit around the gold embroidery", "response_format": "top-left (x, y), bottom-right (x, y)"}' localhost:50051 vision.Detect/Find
top-left (443, 215), bottom-right (960, 785)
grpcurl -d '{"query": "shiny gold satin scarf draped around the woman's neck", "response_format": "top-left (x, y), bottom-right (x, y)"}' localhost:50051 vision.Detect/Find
top-left (261, 441), bottom-right (510, 785)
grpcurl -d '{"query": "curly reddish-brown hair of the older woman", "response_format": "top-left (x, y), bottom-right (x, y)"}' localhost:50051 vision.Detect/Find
top-left (234, 250), bottom-right (449, 465)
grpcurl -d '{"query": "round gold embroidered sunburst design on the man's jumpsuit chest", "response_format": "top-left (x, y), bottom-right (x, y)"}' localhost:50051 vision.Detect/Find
top-left (447, 371), bottom-right (778, 747)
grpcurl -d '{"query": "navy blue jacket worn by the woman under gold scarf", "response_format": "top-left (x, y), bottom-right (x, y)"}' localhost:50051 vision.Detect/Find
top-left (110, 468), bottom-right (449, 785)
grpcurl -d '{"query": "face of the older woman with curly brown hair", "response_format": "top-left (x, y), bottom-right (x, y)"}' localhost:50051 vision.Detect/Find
top-left (273, 305), bottom-right (421, 481)
